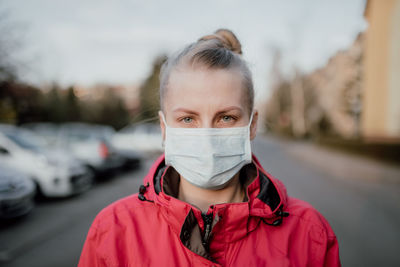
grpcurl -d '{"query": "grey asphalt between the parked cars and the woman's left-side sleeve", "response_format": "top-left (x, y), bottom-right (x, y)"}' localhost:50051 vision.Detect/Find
top-left (0, 160), bottom-right (155, 267)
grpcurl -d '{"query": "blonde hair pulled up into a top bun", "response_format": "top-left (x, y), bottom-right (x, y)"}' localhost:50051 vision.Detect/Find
top-left (160, 29), bottom-right (254, 114)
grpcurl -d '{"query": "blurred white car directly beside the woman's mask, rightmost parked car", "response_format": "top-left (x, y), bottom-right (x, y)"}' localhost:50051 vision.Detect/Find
top-left (112, 123), bottom-right (163, 154)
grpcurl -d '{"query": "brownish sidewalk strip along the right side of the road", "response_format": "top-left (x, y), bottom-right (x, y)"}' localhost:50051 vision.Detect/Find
top-left (271, 137), bottom-right (400, 184)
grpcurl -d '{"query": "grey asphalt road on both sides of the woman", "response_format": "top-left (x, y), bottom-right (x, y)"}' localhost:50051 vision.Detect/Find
top-left (0, 137), bottom-right (400, 267)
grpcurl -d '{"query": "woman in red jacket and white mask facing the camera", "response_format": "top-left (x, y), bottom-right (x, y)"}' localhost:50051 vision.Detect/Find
top-left (79, 30), bottom-right (340, 266)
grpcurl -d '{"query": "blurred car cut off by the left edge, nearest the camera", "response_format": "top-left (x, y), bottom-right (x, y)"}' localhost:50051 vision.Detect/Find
top-left (0, 165), bottom-right (35, 219)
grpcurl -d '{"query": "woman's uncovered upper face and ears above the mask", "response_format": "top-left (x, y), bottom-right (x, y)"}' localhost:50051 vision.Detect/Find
top-left (160, 68), bottom-right (258, 139)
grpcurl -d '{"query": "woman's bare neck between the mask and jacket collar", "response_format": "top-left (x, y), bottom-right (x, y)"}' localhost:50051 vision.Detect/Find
top-left (178, 173), bottom-right (245, 212)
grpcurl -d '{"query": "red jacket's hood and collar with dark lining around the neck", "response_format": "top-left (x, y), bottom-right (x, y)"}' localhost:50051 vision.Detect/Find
top-left (138, 155), bottom-right (289, 261)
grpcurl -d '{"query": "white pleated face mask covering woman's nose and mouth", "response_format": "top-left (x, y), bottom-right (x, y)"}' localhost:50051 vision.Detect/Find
top-left (162, 113), bottom-right (253, 189)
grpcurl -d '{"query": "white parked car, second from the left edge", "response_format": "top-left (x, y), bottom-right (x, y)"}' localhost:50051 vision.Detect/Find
top-left (0, 124), bottom-right (93, 197)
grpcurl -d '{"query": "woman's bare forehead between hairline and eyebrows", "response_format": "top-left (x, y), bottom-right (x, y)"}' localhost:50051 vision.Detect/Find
top-left (164, 68), bottom-right (247, 110)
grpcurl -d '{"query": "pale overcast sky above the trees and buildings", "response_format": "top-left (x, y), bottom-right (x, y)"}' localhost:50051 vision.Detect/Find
top-left (0, 0), bottom-right (367, 99)
